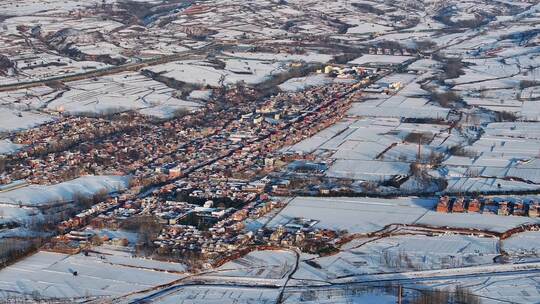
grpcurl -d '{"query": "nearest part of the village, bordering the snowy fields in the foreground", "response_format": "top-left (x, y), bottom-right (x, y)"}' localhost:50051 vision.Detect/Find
top-left (48, 173), bottom-right (344, 261)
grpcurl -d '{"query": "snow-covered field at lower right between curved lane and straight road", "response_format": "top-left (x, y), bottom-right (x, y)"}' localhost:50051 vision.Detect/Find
top-left (294, 235), bottom-right (499, 280)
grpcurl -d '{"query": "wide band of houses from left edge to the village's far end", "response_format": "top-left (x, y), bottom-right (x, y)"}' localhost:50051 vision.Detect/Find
top-left (3, 63), bottom-right (370, 197)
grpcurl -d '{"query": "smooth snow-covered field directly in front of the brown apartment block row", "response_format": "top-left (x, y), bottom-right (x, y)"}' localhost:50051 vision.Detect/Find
top-left (269, 197), bottom-right (540, 233)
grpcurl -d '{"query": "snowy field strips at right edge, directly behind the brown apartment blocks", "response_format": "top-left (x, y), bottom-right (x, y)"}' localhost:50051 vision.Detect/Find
top-left (444, 122), bottom-right (540, 192)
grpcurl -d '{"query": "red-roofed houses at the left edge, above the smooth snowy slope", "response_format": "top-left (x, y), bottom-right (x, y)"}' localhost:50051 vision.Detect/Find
top-left (0, 114), bottom-right (145, 184)
